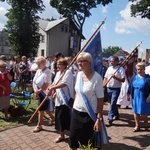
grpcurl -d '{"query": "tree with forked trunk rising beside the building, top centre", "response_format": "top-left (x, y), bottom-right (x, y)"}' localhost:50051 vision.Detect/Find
top-left (50, 0), bottom-right (112, 49)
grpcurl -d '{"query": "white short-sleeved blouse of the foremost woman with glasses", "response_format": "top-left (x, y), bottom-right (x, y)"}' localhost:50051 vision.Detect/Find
top-left (73, 71), bottom-right (104, 113)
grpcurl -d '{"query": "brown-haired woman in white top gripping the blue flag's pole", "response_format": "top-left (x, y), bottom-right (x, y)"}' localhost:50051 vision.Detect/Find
top-left (47, 58), bottom-right (74, 143)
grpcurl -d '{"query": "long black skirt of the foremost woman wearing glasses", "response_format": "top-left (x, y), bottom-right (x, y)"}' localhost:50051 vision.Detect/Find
top-left (69, 109), bottom-right (95, 148)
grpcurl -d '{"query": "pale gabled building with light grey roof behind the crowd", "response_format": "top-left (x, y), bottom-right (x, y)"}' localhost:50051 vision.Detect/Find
top-left (37, 18), bottom-right (84, 57)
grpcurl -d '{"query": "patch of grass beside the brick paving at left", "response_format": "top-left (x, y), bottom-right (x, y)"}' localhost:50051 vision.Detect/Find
top-left (0, 92), bottom-right (38, 131)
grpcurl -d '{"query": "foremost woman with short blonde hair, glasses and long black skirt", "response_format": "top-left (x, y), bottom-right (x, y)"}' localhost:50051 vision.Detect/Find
top-left (69, 52), bottom-right (104, 150)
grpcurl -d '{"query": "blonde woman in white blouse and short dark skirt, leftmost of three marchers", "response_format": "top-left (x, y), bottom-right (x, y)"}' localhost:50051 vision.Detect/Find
top-left (33, 56), bottom-right (55, 132)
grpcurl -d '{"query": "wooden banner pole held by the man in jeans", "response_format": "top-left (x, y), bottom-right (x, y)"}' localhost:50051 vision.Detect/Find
top-left (103, 41), bottom-right (142, 87)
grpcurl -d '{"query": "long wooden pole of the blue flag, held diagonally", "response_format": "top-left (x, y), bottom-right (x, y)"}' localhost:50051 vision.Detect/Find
top-left (28, 18), bottom-right (106, 123)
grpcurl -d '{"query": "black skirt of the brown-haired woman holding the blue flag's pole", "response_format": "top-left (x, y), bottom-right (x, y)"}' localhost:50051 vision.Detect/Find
top-left (55, 105), bottom-right (71, 132)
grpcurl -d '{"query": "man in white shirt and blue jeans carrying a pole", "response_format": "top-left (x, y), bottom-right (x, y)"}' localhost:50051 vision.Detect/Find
top-left (103, 56), bottom-right (125, 127)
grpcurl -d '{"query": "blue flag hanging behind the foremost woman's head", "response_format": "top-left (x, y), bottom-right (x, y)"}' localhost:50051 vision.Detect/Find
top-left (84, 31), bottom-right (103, 76)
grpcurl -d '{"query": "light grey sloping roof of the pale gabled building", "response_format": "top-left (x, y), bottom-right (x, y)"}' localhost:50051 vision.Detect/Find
top-left (39, 18), bottom-right (67, 31)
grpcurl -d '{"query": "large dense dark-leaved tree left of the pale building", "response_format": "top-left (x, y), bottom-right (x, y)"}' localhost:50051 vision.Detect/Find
top-left (5, 0), bottom-right (44, 57)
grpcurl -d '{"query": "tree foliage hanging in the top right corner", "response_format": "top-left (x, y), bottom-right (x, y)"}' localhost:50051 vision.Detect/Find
top-left (130, 0), bottom-right (150, 19)
